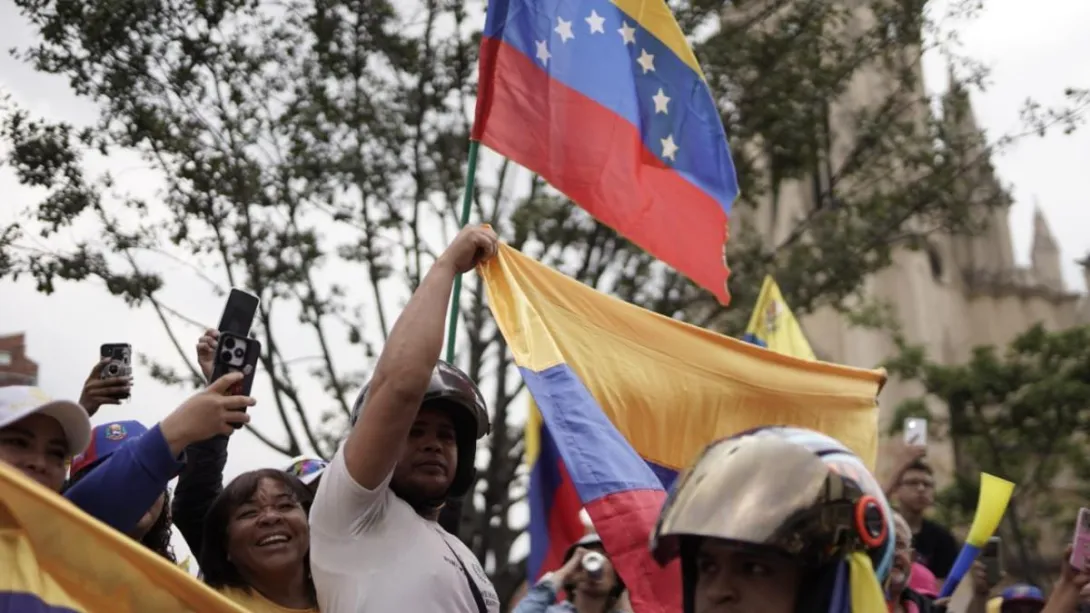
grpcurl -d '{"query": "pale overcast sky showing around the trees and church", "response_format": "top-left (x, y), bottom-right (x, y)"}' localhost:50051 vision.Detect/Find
top-left (0, 0), bottom-right (1090, 562)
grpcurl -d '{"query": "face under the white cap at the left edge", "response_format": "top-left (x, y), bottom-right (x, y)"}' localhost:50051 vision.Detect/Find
top-left (0, 413), bottom-right (70, 492)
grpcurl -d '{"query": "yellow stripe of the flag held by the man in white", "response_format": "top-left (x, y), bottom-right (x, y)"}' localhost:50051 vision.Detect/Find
top-left (480, 245), bottom-right (885, 471)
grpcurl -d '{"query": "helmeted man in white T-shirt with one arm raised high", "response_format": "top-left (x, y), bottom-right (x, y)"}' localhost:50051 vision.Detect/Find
top-left (311, 227), bottom-right (499, 613)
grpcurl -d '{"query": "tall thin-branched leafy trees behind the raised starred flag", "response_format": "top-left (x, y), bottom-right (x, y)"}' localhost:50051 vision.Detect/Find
top-left (0, 0), bottom-right (1086, 599)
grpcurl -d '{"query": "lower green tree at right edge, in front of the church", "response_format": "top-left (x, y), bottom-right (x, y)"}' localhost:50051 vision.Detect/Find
top-left (887, 325), bottom-right (1090, 581)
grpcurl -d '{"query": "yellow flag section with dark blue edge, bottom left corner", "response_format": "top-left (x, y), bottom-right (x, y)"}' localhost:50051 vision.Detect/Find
top-left (0, 462), bottom-right (245, 613)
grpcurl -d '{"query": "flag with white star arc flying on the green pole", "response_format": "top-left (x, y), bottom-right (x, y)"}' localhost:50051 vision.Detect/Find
top-left (472, 0), bottom-right (738, 304)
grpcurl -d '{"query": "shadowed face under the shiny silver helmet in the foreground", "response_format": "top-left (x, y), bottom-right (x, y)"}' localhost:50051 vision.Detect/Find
top-left (693, 539), bottom-right (802, 613)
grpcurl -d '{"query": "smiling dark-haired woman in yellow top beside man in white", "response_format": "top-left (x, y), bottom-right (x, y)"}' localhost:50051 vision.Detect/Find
top-left (197, 469), bottom-right (317, 613)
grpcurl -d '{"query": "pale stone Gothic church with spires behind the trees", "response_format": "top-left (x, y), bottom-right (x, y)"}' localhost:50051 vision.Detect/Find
top-left (727, 3), bottom-right (1090, 474)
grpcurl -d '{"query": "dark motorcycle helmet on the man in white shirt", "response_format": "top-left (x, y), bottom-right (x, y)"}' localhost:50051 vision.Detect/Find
top-left (351, 360), bottom-right (492, 498)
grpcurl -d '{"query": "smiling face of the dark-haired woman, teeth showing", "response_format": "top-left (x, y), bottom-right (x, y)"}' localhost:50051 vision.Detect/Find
top-left (227, 479), bottom-right (311, 579)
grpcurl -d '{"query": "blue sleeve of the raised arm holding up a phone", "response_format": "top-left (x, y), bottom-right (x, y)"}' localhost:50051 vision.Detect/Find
top-left (64, 424), bottom-right (185, 534)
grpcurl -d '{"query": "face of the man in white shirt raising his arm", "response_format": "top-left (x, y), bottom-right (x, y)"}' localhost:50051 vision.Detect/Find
top-left (393, 406), bottom-right (458, 498)
